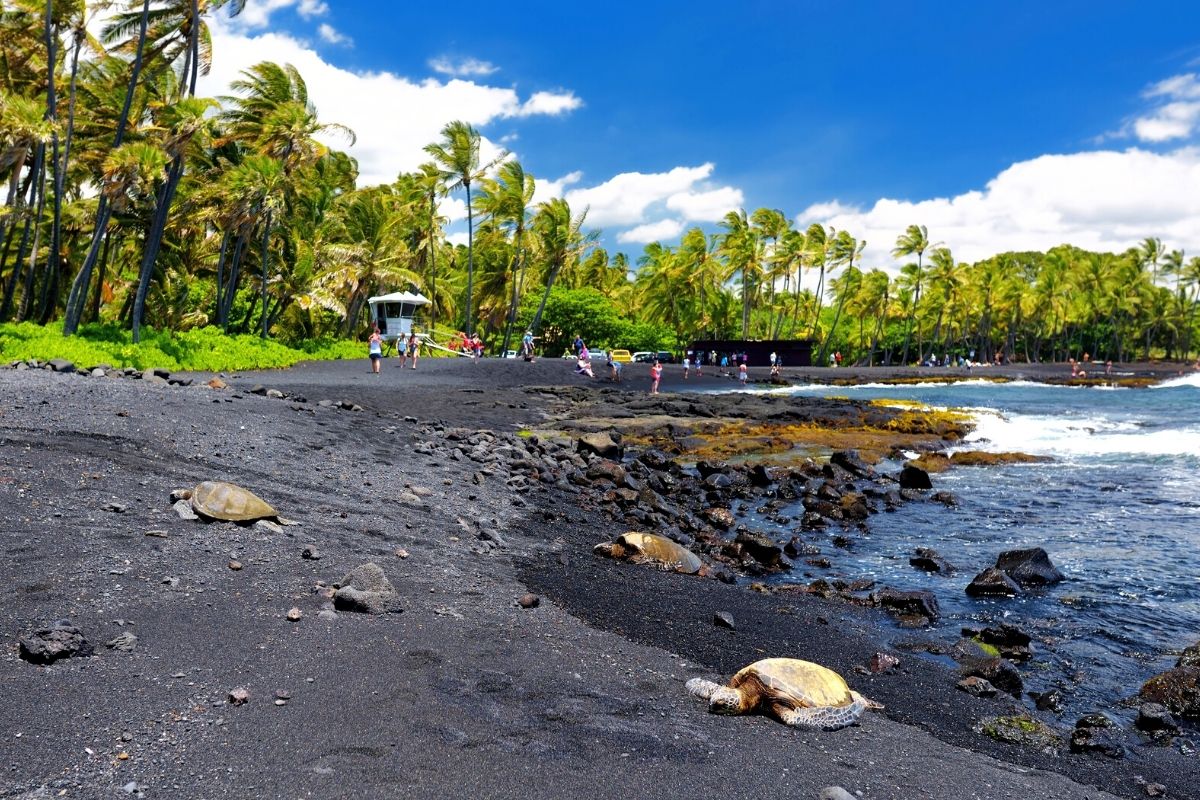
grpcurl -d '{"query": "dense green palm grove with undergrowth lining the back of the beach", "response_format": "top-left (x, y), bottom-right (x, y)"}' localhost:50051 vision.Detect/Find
top-left (0, 0), bottom-right (1200, 366)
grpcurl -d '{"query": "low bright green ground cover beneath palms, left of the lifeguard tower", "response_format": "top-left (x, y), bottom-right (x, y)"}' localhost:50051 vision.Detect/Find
top-left (0, 323), bottom-right (366, 372)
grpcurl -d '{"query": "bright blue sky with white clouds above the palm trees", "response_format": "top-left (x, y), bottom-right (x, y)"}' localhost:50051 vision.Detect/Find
top-left (196, 0), bottom-right (1200, 259)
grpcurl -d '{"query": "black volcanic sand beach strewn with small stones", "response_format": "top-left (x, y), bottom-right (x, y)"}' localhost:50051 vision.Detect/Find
top-left (0, 360), bottom-right (1200, 800)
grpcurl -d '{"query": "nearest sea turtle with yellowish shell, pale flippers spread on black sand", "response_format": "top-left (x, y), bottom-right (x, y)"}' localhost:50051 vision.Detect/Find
top-left (686, 658), bottom-right (883, 730)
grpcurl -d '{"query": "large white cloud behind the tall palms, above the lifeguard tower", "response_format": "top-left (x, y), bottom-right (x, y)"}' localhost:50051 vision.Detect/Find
top-left (199, 14), bottom-right (574, 186)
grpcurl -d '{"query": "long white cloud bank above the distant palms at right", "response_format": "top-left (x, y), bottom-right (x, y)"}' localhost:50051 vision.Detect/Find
top-left (797, 148), bottom-right (1200, 267)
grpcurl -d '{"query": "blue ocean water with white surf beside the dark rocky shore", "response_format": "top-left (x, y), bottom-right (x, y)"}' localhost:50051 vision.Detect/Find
top-left (768, 374), bottom-right (1200, 721)
